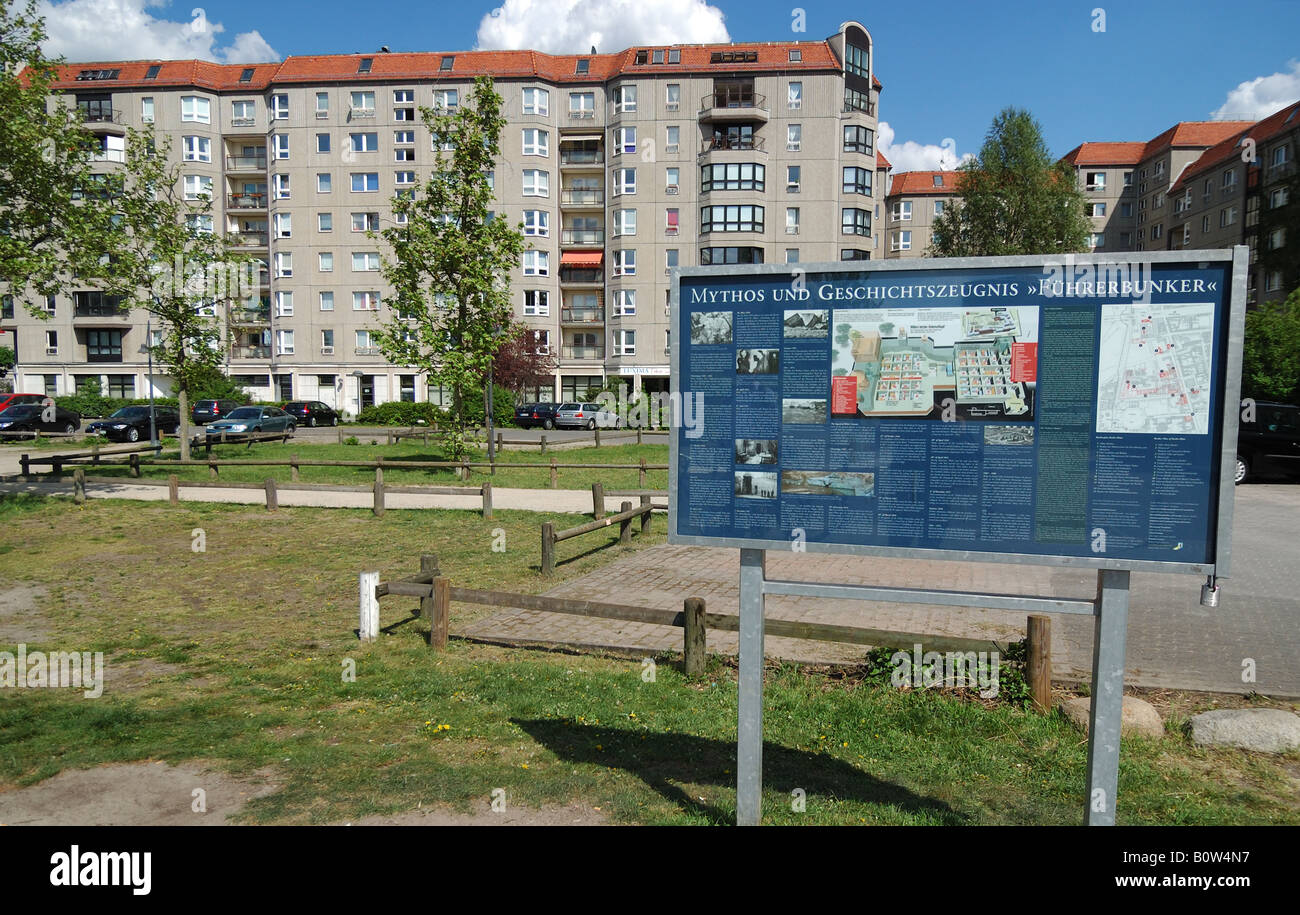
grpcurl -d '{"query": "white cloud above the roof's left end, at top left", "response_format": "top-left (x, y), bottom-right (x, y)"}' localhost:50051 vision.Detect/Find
top-left (40, 0), bottom-right (280, 64)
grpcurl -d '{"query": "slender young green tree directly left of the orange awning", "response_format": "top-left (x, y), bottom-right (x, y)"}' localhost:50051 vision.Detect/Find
top-left (374, 77), bottom-right (524, 458)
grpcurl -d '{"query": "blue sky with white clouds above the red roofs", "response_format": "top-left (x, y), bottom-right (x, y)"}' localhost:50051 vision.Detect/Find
top-left (35, 0), bottom-right (1300, 168)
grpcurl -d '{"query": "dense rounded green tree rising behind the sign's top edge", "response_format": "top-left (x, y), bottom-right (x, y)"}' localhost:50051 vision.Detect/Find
top-left (928, 108), bottom-right (1091, 257)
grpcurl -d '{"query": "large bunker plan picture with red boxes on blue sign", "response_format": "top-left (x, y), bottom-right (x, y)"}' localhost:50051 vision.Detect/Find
top-left (832, 307), bottom-right (1037, 420)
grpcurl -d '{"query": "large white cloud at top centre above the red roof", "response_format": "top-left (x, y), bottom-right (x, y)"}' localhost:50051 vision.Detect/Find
top-left (478, 0), bottom-right (731, 55)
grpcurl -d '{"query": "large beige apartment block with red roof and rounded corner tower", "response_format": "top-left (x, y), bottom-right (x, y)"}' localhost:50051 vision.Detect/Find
top-left (0, 22), bottom-right (888, 413)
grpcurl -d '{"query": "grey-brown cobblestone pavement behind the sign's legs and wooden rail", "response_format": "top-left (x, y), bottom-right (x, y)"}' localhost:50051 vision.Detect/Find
top-left (460, 483), bottom-right (1300, 697)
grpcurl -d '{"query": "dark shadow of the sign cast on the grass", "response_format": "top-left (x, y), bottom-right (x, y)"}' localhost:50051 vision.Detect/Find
top-left (511, 717), bottom-right (969, 825)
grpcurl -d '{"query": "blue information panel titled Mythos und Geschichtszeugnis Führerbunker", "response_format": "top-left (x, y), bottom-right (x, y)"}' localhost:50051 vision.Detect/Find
top-left (672, 252), bottom-right (1238, 567)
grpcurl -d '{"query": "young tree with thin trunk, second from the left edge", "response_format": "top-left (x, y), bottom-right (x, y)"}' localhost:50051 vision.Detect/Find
top-left (100, 131), bottom-right (248, 459)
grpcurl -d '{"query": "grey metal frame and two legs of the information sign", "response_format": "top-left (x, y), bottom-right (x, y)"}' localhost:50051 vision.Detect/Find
top-left (668, 246), bottom-right (1249, 825)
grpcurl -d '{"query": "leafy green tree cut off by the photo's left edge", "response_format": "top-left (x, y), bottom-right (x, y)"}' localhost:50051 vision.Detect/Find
top-left (0, 0), bottom-right (112, 310)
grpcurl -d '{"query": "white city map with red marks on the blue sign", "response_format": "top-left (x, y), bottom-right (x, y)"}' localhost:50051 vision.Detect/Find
top-left (1097, 303), bottom-right (1214, 435)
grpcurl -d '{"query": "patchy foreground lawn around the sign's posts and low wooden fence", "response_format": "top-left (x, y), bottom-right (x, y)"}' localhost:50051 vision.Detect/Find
top-left (0, 493), bottom-right (1300, 824)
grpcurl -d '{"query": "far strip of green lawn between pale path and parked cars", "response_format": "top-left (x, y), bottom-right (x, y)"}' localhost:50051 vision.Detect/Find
top-left (36, 438), bottom-right (668, 490)
